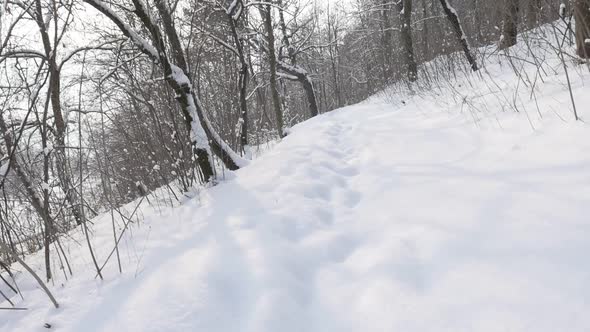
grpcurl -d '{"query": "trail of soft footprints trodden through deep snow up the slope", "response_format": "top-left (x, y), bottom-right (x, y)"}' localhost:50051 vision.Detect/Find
top-left (221, 123), bottom-right (370, 319)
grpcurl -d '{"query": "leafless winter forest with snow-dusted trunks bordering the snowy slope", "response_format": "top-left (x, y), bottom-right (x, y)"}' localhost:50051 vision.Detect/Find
top-left (0, 0), bottom-right (590, 331)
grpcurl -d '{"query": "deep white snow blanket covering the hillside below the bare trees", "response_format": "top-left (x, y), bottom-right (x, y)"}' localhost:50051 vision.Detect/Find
top-left (0, 27), bottom-right (590, 332)
